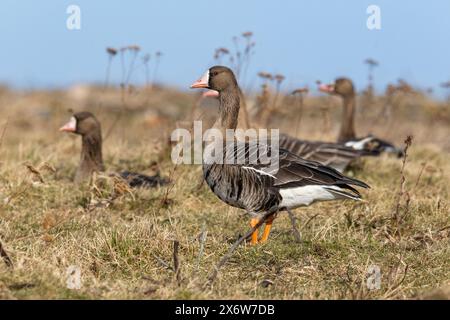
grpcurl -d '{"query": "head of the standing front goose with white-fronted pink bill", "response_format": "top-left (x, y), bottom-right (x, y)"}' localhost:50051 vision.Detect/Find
top-left (191, 66), bottom-right (237, 93)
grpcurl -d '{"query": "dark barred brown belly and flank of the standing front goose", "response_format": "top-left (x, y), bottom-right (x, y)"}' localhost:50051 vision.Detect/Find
top-left (203, 164), bottom-right (281, 213)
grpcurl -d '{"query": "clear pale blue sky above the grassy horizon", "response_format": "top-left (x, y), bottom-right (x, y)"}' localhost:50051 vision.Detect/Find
top-left (0, 0), bottom-right (450, 93)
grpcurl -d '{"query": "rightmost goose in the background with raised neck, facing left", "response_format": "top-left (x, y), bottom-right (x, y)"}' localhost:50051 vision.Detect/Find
top-left (319, 78), bottom-right (403, 158)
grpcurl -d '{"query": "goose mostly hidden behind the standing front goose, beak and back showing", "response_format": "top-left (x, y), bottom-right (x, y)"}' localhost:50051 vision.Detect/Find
top-left (203, 90), bottom-right (378, 172)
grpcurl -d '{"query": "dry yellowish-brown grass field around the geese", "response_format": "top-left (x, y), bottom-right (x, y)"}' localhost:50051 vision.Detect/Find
top-left (0, 87), bottom-right (450, 299)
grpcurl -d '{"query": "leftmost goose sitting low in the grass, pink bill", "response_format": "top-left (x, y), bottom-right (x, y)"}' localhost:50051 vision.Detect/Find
top-left (59, 111), bottom-right (168, 188)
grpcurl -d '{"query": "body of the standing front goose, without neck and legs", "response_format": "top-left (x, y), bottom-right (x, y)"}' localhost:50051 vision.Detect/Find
top-left (203, 143), bottom-right (367, 216)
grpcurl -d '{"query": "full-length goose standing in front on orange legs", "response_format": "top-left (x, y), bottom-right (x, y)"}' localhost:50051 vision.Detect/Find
top-left (191, 66), bottom-right (369, 244)
